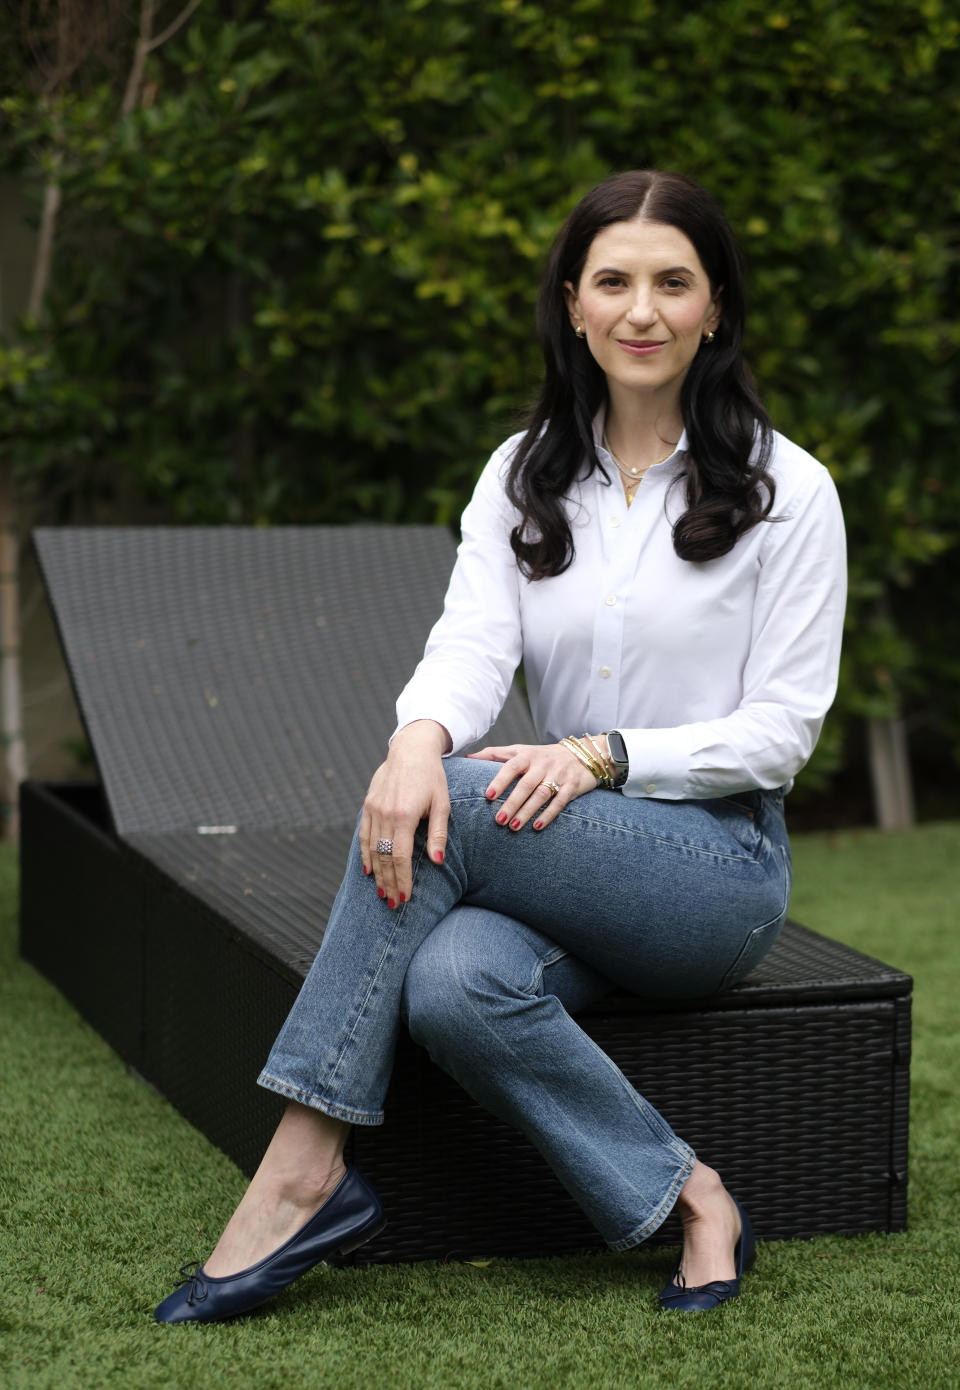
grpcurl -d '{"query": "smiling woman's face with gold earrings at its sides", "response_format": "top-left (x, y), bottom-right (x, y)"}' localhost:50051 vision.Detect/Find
top-left (564, 217), bottom-right (720, 403)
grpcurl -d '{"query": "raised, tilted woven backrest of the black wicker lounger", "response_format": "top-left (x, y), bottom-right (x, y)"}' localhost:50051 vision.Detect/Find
top-left (35, 527), bottom-right (533, 834)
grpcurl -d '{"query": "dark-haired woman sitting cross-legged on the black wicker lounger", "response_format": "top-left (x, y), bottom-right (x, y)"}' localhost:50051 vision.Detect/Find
top-left (157, 172), bottom-right (845, 1322)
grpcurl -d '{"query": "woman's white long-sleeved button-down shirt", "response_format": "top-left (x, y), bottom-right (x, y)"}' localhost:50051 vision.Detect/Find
top-left (397, 418), bottom-right (846, 799)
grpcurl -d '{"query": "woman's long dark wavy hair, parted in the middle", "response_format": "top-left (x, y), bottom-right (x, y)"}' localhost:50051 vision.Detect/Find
top-left (507, 170), bottom-right (774, 580)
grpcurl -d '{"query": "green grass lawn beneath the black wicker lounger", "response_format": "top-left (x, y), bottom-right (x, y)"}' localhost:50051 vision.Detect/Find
top-left (0, 823), bottom-right (960, 1390)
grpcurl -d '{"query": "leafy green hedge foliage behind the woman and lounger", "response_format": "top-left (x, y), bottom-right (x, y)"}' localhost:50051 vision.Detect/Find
top-left (0, 0), bottom-right (960, 811)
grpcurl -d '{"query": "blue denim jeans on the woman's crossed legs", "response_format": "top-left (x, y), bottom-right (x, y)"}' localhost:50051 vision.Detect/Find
top-left (260, 758), bottom-right (791, 1250)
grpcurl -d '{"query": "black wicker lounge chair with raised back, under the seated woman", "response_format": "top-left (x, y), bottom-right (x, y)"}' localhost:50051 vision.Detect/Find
top-left (22, 527), bottom-right (911, 1261)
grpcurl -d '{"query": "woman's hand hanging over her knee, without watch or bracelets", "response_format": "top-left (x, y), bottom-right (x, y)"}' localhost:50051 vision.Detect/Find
top-left (360, 719), bottom-right (450, 908)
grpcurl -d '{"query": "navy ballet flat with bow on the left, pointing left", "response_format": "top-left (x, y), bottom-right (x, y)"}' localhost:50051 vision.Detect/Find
top-left (154, 1168), bottom-right (386, 1322)
